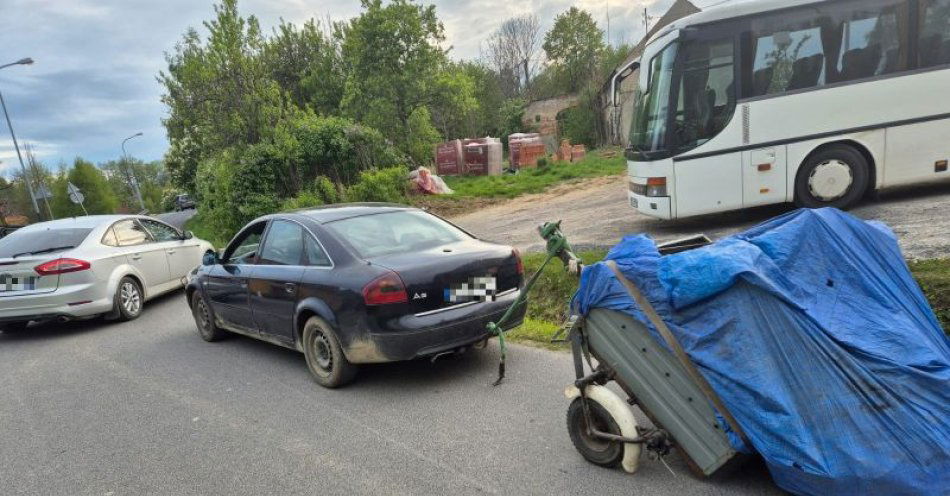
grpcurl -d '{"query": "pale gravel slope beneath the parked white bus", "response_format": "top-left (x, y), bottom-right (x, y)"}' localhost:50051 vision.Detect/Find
top-left (452, 176), bottom-right (950, 258)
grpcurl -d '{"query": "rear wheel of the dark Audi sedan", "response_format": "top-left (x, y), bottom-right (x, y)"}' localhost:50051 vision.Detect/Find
top-left (303, 317), bottom-right (356, 388)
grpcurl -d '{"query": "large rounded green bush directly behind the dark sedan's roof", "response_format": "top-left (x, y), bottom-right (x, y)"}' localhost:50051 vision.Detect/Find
top-left (195, 114), bottom-right (406, 242)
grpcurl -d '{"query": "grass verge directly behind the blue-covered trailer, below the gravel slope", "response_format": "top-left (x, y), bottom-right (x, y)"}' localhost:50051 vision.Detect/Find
top-left (508, 251), bottom-right (950, 349)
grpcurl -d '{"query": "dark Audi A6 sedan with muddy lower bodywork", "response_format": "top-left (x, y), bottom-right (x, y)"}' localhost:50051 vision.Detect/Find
top-left (186, 204), bottom-right (524, 387)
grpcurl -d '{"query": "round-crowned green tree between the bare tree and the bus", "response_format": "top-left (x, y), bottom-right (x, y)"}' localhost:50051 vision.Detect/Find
top-left (544, 7), bottom-right (605, 92)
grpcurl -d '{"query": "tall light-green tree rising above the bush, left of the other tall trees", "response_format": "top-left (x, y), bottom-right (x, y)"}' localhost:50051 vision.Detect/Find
top-left (158, 0), bottom-right (289, 191)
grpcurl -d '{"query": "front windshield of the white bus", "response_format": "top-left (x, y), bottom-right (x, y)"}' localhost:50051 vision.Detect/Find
top-left (630, 42), bottom-right (678, 157)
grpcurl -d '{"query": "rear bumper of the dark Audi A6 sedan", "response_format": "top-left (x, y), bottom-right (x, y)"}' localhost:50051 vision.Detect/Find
top-left (345, 292), bottom-right (526, 363)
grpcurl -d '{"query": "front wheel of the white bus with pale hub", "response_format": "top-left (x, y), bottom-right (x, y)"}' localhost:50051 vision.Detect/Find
top-left (795, 145), bottom-right (868, 209)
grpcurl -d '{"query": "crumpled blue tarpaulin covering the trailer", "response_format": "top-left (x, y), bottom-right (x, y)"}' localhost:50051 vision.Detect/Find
top-left (574, 209), bottom-right (950, 495)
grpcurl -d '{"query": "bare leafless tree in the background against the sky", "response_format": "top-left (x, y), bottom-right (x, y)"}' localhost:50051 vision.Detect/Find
top-left (488, 15), bottom-right (541, 97)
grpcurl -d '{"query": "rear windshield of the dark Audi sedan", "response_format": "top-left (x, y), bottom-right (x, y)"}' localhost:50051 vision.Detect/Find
top-left (326, 210), bottom-right (471, 258)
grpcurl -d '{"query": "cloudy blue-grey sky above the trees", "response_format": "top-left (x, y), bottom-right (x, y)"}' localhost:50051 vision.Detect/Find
top-left (0, 0), bottom-right (684, 175)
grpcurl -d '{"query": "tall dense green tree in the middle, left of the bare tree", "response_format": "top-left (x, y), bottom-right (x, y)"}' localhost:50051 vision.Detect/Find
top-left (339, 0), bottom-right (462, 161)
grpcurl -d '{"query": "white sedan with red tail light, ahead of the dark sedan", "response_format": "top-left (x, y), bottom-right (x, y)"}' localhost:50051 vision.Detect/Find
top-left (0, 215), bottom-right (214, 331)
